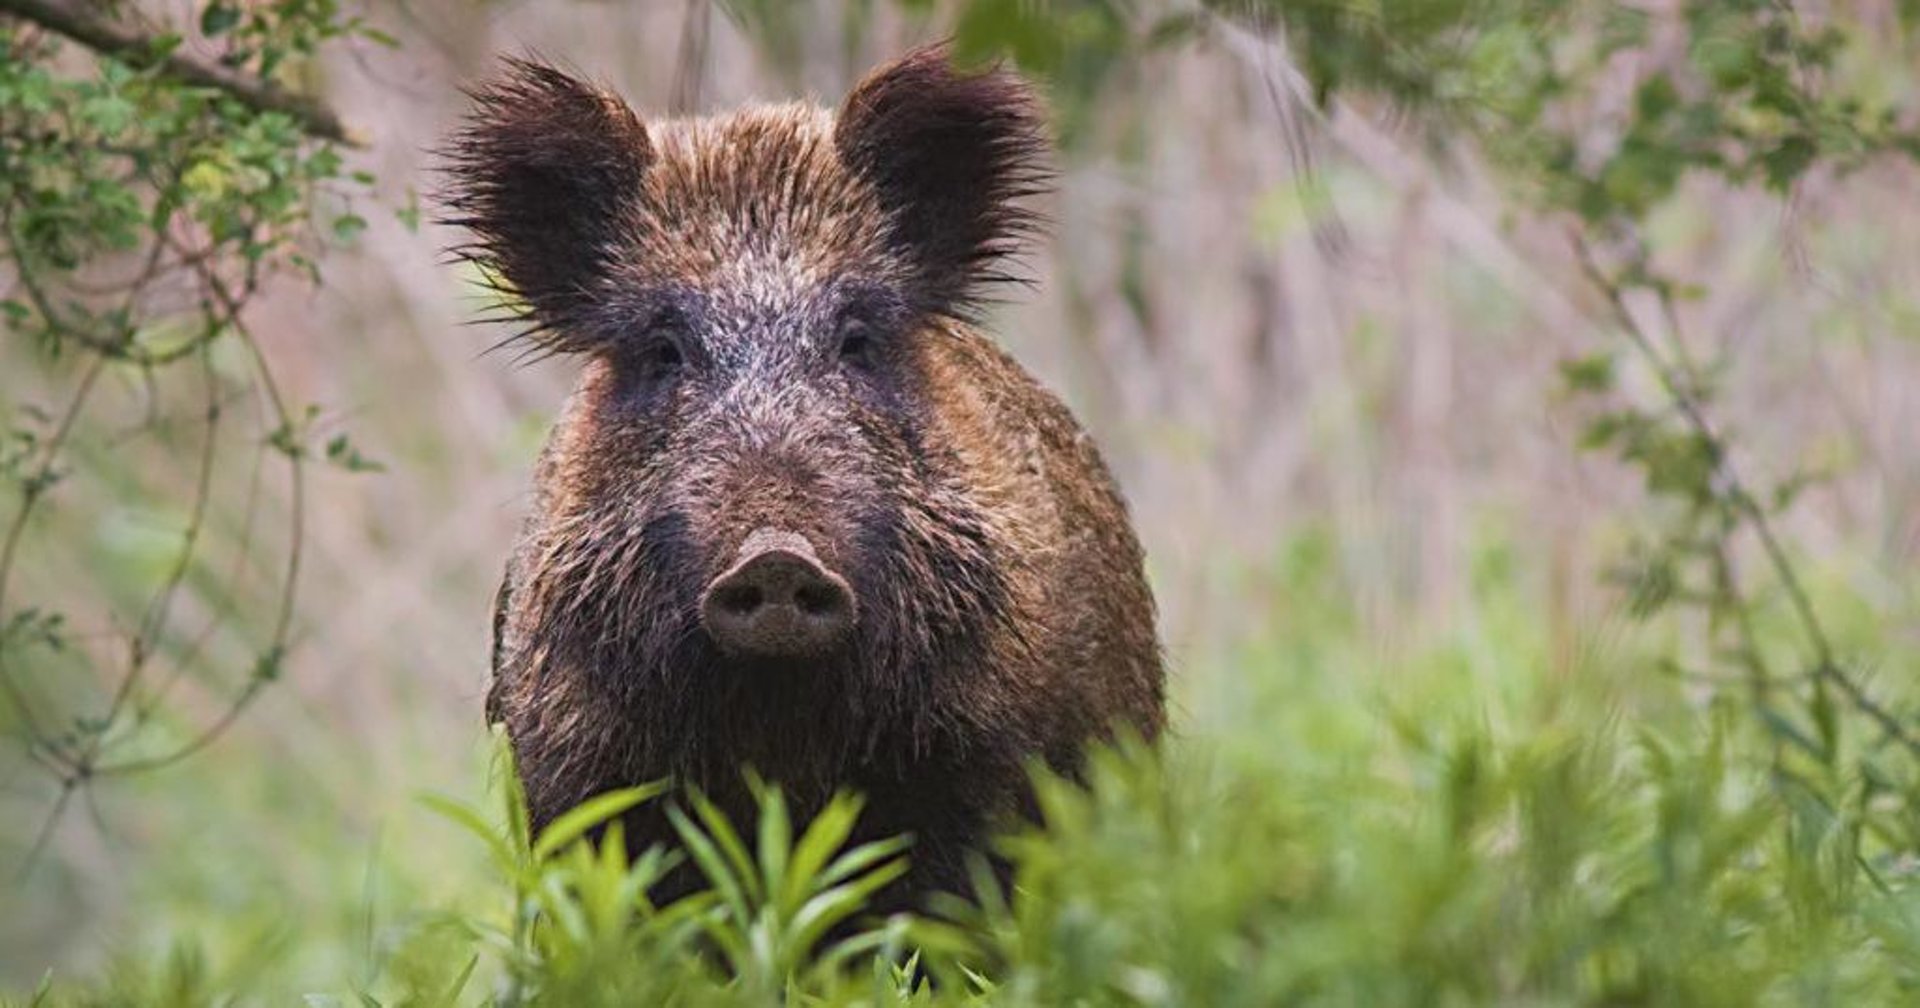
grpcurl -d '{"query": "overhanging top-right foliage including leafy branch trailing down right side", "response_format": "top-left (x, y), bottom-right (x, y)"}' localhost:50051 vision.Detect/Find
top-left (948, 0), bottom-right (1920, 975)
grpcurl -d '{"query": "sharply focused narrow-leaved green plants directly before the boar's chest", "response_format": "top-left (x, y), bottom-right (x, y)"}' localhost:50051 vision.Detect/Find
top-left (384, 735), bottom-right (935, 1006)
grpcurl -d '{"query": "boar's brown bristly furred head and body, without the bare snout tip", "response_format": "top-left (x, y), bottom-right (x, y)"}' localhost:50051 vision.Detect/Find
top-left (447, 48), bottom-right (1164, 904)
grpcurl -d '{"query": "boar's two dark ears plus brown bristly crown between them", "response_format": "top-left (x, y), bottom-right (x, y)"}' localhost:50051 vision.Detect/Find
top-left (442, 46), bottom-right (1052, 345)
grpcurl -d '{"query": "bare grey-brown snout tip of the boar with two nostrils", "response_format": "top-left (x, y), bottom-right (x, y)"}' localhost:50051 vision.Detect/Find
top-left (701, 528), bottom-right (854, 659)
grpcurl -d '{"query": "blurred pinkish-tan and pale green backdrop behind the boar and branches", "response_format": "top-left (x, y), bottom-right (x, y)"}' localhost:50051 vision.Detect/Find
top-left (0, 0), bottom-right (1920, 989)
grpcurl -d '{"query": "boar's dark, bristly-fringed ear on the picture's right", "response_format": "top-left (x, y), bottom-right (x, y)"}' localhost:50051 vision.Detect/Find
top-left (833, 46), bottom-right (1050, 317)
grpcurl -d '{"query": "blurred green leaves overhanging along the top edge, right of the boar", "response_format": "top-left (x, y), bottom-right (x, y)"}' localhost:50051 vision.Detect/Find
top-left (936, 0), bottom-right (1920, 204)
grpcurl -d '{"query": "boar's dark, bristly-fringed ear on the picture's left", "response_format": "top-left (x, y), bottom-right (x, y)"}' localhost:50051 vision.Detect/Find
top-left (442, 60), bottom-right (653, 351)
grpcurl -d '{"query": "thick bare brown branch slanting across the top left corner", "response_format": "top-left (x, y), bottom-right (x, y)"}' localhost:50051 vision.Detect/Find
top-left (0, 0), bottom-right (367, 148)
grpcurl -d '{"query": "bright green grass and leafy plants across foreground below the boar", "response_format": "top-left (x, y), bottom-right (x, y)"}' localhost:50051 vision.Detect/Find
top-left (15, 541), bottom-right (1920, 1006)
